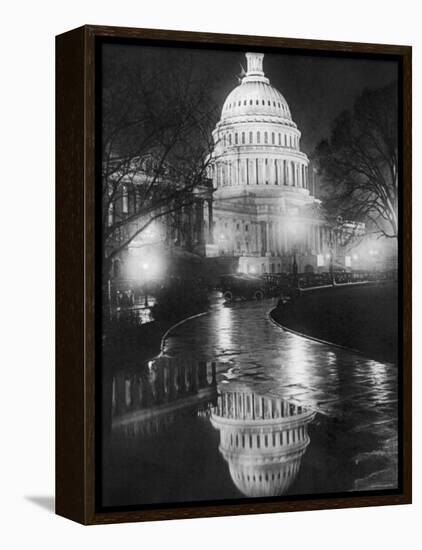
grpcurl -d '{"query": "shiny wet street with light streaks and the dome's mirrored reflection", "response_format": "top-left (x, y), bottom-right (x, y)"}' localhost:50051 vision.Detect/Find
top-left (103, 300), bottom-right (397, 506)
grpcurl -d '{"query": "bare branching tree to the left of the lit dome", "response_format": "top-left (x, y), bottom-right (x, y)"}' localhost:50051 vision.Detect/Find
top-left (102, 46), bottom-right (221, 280)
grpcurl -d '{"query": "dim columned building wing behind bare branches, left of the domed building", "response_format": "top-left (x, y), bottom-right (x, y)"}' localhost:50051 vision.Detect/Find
top-left (104, 156), bottom-right (213, 281)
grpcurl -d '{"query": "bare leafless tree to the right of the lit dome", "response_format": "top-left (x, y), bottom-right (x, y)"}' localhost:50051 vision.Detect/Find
top-left (313, 82), bottom-right (398, 238)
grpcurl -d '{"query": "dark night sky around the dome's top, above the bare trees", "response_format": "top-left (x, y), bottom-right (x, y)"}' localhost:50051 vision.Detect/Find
top-left (103, 44), bottom-right (398, 158)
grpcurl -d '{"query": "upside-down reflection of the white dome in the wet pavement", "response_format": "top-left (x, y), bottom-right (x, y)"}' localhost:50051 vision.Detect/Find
top-left (211, 388), bottom-right (315, 497)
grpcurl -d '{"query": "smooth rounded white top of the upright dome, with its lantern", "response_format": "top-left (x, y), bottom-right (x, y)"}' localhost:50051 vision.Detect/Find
top-left (221, 53), bottom-right (295, 126)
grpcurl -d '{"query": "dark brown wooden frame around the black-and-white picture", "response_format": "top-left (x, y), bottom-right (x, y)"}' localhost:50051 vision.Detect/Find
top-left (56, 25), bottom-right (412, 524)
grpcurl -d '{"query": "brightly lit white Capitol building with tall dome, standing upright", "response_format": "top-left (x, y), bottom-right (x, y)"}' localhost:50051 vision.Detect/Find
top-left (212, 53), bottom-right (348, 274)
